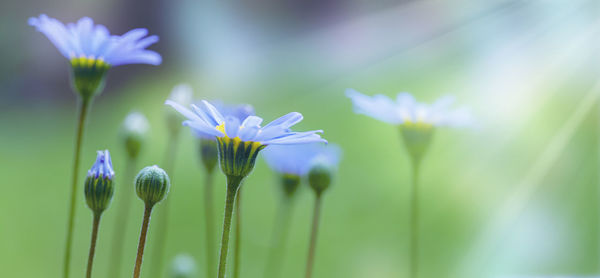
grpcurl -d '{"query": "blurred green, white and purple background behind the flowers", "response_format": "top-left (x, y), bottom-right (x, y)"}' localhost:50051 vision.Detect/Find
top-left (0, 0), bottom-right (600, 278)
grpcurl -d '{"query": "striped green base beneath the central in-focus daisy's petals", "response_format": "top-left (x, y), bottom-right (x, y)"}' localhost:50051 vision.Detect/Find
top-left (217, 136), bottom-right (266, 178)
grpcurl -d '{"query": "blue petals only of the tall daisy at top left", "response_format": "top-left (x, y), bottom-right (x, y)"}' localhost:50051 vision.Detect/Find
top-left (29, 14), bottom-right (162, 66)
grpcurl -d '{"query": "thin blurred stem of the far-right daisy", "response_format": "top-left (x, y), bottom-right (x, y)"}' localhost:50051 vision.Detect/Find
top-left (409, 159), bottom-right (421, 278)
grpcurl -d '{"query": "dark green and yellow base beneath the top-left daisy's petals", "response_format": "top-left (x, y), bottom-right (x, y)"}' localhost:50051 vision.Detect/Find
top-left (71, 57), bottom-right (110, 100)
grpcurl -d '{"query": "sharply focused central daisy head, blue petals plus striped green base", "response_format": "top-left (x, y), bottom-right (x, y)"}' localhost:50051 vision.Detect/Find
top-left (166, 100), bottom-right (326, 178)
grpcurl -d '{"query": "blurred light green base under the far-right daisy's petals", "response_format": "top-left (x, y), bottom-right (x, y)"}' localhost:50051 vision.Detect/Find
top-left (400, 123), bottom-right (434, 160)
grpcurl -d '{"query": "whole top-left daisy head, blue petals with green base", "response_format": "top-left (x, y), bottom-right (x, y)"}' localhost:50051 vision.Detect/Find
top-left (29, 14), bottom-right (162, 98)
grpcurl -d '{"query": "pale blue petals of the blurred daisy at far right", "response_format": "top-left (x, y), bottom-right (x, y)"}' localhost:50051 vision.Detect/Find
top-left (346, 89), bottom-right (471, 126)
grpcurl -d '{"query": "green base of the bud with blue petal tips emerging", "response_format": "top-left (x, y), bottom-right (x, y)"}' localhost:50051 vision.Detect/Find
top-left (84, 176), bottom-right (114, 213)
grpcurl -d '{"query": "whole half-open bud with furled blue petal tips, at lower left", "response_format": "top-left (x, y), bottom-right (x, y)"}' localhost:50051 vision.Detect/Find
top-left (84, 150), bottom-right (115, 213)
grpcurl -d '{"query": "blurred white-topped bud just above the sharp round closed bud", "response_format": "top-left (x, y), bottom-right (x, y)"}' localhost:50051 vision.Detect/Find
top-left (121, 112), bottom-right (149, 158)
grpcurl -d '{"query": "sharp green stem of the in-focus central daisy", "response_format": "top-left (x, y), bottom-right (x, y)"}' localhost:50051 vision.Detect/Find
top-left (217, 176), bottom-right (242, 278)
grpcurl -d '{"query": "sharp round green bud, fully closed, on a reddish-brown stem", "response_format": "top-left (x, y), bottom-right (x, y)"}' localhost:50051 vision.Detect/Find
top-left (135, 165), bottom-right (171, 206)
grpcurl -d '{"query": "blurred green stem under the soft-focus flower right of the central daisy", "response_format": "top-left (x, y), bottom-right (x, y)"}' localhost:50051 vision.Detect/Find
top-left (265, 197), bottom-right (292, 278)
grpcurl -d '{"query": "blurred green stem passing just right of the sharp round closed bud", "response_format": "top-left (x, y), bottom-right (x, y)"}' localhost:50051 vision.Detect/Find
top-left (151, 133), bottom-right (179, 277)
